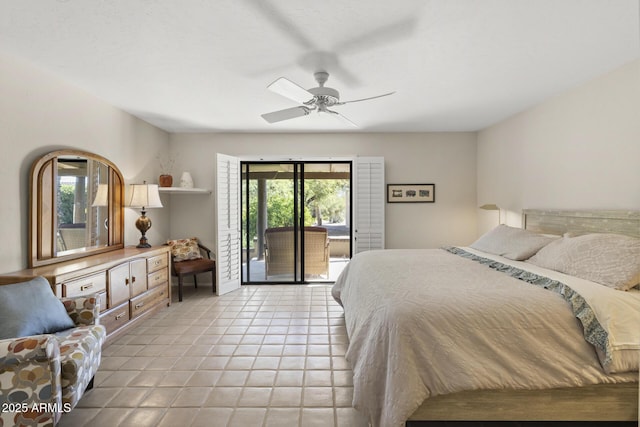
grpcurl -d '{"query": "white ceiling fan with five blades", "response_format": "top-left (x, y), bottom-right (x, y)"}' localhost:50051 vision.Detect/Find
top-left (262, 71), bottom-right (395, 127)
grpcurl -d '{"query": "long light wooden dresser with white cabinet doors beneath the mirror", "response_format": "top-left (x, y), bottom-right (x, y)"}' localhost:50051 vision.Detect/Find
top-left (0, 246), bottom-right (171, 342)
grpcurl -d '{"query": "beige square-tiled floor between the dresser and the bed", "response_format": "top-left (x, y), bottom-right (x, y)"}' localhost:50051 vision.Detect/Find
top-left (59, 285), bottom-right (368, 427)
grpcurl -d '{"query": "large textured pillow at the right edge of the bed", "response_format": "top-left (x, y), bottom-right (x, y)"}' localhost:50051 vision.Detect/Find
top-left (527, 233), bottom-right (640, 291)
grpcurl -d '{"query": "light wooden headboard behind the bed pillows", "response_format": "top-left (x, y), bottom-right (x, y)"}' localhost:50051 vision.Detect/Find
top-left (522, 209), bottom-right (640, 237)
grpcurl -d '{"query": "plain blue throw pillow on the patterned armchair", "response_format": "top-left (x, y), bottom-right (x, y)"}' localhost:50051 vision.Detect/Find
top-left (0, 277), bottom-right (75, 339)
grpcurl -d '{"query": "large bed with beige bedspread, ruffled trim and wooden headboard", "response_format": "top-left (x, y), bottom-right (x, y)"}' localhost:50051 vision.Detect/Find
top-left (333, 210), bottom-right (640, 427)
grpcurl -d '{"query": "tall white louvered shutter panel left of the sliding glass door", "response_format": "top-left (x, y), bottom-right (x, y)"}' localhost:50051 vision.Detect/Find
top-left (216, 153), bottom-right (242, 295)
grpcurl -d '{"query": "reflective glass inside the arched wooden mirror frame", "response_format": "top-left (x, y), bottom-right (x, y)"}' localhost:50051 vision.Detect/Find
top-left (57, 157), bottom-right (108, 255)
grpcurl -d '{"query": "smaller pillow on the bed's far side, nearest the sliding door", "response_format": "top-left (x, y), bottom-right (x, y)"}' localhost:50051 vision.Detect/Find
top-left (470, 224), bottom-right (557, 261)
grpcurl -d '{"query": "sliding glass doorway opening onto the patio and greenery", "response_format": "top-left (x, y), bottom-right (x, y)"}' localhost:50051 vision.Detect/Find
top-left (240, 161), bottom-right (352, 284)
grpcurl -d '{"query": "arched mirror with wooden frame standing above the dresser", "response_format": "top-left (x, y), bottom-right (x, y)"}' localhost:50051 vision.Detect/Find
top-left (29, 150), bottom-right (124, 268)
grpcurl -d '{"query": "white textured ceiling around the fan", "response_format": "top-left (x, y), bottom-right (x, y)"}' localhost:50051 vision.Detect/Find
top-left (0, 0), bottom-right (640, 132)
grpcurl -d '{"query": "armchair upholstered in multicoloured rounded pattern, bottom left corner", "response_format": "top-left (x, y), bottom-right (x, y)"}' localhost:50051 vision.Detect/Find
top-left (0, 279), bottom-right (106, 426)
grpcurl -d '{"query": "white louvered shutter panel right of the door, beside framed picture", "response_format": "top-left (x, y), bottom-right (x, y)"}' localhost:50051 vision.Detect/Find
top-left (353, 157), bottom-right (385, 254)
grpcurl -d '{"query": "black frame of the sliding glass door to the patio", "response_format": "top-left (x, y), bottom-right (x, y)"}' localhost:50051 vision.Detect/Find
top-left (240, 158), bottom-right (354, 285)
